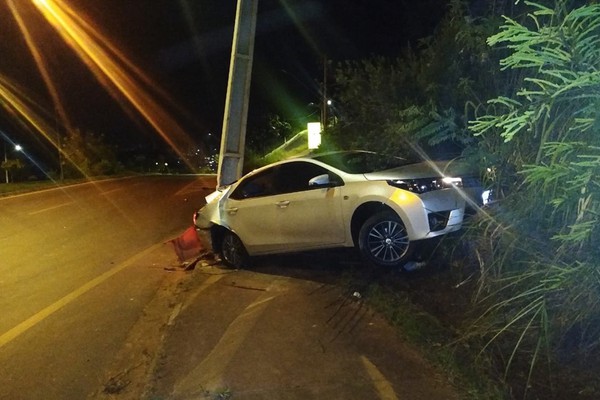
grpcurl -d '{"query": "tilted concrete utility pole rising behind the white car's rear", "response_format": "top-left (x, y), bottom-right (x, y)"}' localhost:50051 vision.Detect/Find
top-left (217, 0), bottom-right (258, 186)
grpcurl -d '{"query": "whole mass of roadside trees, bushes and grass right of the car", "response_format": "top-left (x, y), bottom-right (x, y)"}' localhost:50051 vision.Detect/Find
top-left (245, 0), bottom-right (600, 399)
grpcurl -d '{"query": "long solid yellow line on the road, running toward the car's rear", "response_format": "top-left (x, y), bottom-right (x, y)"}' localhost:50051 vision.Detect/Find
top-left (0, 243), bottom-right (163, 348)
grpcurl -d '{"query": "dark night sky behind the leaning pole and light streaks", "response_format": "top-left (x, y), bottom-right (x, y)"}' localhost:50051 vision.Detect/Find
top-left (0, 0), bottom-right (448, 161)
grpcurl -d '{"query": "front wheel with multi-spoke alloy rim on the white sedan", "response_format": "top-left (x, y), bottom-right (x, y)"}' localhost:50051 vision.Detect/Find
top-left (358, 211), bottom-right (413, 268)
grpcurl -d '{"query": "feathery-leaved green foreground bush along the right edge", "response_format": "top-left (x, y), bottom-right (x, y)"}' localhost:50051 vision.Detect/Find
top-left (468, 1), bottom-right (600, 396)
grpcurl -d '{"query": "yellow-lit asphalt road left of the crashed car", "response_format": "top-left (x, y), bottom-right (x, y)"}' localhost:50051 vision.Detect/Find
top-left (0, 176), bottom-right (214, 400)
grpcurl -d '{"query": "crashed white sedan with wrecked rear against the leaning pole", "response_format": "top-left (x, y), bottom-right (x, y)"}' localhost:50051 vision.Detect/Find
top-left (194, 151), bottom-right (465, 268)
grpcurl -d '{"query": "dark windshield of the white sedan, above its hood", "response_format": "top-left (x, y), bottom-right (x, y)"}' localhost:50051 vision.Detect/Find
top-left (314, 151), bottom-right (413, 174)
